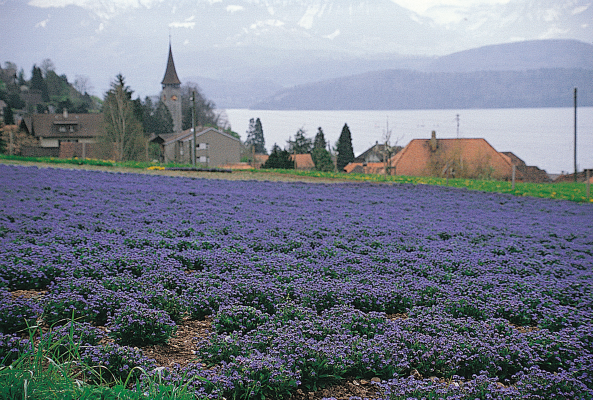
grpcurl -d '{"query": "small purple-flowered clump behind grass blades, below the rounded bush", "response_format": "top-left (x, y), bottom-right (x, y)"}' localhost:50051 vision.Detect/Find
top-left (81, 344), bottom-right (156, 383)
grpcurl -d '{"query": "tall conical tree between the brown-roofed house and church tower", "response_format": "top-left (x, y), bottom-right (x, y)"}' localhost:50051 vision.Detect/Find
top-left (102, 74), bottom-right (146, 161)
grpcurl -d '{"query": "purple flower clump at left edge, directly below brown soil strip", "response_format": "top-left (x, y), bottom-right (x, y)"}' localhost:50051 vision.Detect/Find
top-left (0, 291), bottom-right (43, 333)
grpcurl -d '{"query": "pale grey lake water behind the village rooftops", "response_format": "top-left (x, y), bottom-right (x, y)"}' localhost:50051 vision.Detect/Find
top-left (226, 107), bottom-right (593, 174)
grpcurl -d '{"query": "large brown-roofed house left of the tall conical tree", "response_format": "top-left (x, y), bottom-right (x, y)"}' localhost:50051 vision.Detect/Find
top-left (21, 110), bottom-right (104, 158)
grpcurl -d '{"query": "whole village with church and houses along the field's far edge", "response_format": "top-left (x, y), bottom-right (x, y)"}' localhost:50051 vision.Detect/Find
top-left (0, 46), bottom-right (584, 183)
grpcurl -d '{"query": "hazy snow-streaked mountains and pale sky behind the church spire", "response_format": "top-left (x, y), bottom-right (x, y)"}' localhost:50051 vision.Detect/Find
top-left (0, 0), bottom-right (593, 100)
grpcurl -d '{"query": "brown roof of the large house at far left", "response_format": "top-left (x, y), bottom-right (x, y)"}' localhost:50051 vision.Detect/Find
top-left (22, 114), bottom-right (104, 139)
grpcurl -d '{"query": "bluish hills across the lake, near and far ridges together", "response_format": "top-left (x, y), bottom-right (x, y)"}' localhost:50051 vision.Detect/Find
top-left (194, 40), bottom-right (593, 110)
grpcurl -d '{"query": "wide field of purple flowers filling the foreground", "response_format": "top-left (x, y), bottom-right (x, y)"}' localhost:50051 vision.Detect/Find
top-left (0, 165), bottom-right (593, 399)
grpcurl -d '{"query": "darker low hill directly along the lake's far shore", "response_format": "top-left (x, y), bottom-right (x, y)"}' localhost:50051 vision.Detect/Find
top-left (253, 69), bottom-right (593, 110)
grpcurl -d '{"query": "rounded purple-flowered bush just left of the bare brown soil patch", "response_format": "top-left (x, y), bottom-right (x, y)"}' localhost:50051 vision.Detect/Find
top-left (107, 303), bottom-right (177, 346)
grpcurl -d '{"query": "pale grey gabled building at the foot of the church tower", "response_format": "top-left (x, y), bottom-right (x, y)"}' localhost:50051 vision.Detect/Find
top-left (150, 128), bottom-right (241, 168)
